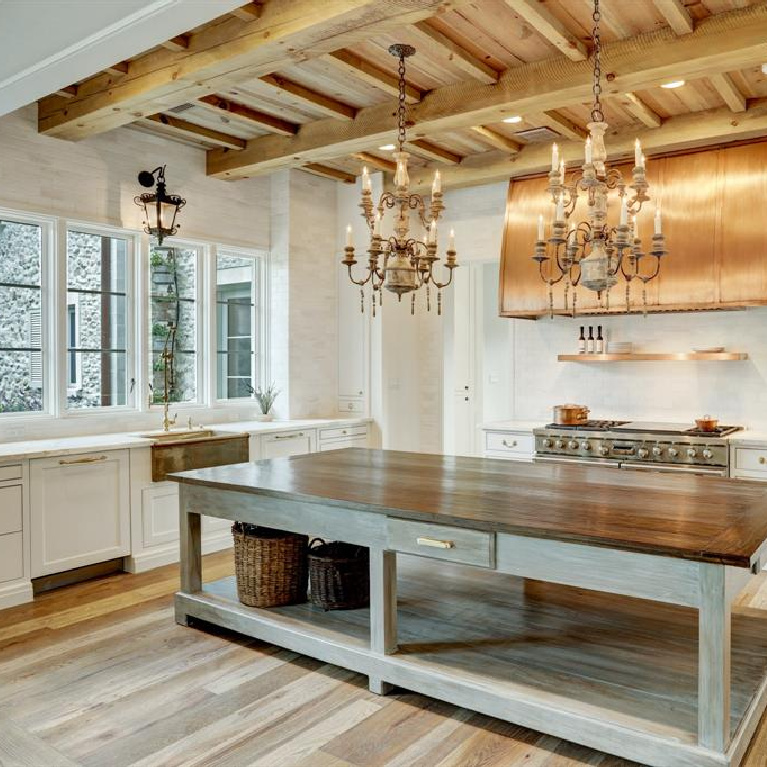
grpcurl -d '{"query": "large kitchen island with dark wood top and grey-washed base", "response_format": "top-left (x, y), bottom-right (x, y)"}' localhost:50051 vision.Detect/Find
top-left (171, 449), bottom-right (767, 767)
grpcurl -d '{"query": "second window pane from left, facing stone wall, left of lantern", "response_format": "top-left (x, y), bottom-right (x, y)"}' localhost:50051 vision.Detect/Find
top-left (66, 230), bottom-right (130, 410)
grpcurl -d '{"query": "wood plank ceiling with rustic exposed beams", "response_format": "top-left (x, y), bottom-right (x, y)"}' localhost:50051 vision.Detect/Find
top-left (39, 0), bottom-right (767, 187)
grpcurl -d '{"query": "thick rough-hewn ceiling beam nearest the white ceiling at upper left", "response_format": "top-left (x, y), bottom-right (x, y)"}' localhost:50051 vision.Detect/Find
top-left (38, 0), bottom-right (467, 140)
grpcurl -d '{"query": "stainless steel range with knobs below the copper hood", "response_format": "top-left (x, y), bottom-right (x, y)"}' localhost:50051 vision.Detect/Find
top-left (533, 421), bottom-right (743, 477)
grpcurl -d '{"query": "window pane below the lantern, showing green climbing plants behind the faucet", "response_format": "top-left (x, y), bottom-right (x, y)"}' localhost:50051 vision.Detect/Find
top-left (149, 246), bottom-right (199, 402)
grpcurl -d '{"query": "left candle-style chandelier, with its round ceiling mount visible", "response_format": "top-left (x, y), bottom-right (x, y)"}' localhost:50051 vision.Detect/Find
top-left (341, 44), bottom-right (458, 317)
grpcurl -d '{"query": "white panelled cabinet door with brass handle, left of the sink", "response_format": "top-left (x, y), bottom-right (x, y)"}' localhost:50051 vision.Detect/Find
top-left (30, 450), bottom-right (130, 577)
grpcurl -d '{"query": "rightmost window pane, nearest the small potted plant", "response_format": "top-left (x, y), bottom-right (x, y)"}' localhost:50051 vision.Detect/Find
top-left (216, 254), bottom-right (260, 399)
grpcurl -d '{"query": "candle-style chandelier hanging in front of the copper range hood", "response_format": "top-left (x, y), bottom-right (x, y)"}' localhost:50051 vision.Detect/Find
top-left (533, 0), bottom-right (668, 317)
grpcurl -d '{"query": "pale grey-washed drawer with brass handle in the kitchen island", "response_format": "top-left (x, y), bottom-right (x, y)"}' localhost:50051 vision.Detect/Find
top-left (387, 519), bottom-right (495, 567)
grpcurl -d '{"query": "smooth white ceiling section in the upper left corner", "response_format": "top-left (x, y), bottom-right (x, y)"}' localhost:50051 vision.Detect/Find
top-left (0, 0), bottom-right (244, 115)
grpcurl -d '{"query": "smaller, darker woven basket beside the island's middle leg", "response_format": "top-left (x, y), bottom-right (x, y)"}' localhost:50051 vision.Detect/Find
top-left (309, 538), bottom-right (370, 610)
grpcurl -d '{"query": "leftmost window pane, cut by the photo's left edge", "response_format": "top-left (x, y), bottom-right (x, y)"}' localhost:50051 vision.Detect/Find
top-left (0, 220), bottom-right (44, 413)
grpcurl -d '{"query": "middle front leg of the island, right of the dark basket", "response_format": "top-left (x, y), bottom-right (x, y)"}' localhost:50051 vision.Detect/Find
top-left (368, 549), bottom-right (397, 695)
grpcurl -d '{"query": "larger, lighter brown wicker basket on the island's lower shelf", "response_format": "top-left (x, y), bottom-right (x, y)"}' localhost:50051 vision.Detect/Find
top-left (232, 522), bottom-right (309, 607)
